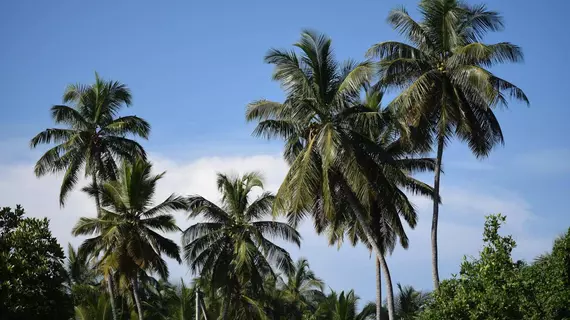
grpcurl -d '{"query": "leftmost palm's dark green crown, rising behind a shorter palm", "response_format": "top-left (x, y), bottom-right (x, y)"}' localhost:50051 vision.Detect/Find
top-left (30, 73), bottom-right (150, 212)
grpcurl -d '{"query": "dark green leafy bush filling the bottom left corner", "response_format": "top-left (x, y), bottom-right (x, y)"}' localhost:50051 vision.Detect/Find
top-left (0, 206), bottom-right (73, 319)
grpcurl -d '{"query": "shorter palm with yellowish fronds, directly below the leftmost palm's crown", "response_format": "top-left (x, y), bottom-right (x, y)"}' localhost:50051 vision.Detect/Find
top-left (72, 159), bottom-right (182, 319)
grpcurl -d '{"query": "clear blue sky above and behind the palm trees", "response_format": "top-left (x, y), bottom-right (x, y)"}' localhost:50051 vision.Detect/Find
top-left (0, 0), bottom-right (570, 299)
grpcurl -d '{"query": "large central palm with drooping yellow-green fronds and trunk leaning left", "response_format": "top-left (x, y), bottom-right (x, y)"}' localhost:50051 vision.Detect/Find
top-left (246, 31), bottom-right (390, 284)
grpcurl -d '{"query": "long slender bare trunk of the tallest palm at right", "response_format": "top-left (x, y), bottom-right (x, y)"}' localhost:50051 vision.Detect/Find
top-left (431, 135), bottom-right (444, 291)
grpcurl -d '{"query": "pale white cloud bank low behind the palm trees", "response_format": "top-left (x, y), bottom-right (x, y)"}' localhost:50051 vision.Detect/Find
top-left (0, 155), bottom-right (554, 300)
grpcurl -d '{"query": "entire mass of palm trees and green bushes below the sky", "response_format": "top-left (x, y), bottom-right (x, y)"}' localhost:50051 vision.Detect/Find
top-left (0, 0), bottom-right (570, 320)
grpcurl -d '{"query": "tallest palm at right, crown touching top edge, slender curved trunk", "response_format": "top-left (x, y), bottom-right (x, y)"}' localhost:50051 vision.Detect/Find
top-left (368, 0), bottom-right (528, 290)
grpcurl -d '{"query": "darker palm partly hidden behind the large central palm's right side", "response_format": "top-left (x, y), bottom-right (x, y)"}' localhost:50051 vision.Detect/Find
top-left (328, 84), bottom-right (435, 320)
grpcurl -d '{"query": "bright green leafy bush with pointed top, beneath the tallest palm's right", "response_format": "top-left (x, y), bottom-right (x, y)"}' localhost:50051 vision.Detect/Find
top-left (422, 215), bottom-right (545, 320)
